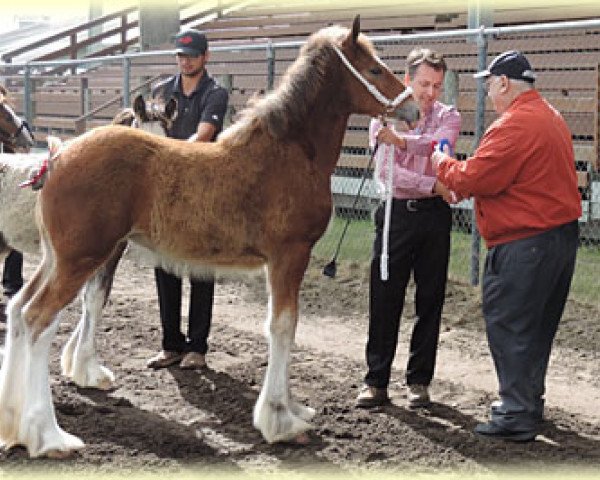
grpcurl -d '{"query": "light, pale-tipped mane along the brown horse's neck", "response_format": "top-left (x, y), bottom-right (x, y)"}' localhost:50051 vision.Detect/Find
top-left (219, 26), bottom-right (374, 145)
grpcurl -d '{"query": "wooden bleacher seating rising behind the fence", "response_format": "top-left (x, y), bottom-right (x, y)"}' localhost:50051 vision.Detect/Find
top-left (3, 0), bottom-right (600, 193)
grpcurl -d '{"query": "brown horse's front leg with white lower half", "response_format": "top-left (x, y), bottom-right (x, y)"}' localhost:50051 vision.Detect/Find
top-left (254, 244), bottom-right (314, 443)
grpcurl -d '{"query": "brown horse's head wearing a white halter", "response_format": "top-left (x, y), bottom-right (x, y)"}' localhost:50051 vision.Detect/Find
top-left (333, 15), bottom-right (419, 122)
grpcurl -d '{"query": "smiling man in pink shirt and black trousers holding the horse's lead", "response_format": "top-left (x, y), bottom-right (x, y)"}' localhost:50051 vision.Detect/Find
top-left (356, 48), bottom-right (460, 408)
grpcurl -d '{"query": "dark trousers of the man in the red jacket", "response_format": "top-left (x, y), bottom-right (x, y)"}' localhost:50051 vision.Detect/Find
top-left (482, 221), bottom-right (579, 431)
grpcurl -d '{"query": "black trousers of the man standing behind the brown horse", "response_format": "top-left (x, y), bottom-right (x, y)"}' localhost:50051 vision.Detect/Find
top-left (154, 268), bottom-right (215, 354)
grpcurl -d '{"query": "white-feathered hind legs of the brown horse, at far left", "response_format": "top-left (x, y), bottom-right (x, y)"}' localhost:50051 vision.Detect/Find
top-left (0, 254), bottom-right (98, 457)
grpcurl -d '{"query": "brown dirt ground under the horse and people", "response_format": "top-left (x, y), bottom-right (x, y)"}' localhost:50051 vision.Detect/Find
top-left (0, 253), bottom-right (600, 476)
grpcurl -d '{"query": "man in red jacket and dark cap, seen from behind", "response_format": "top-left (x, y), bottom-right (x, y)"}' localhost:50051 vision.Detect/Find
top-left (431, 50), bottom-right (581, 441)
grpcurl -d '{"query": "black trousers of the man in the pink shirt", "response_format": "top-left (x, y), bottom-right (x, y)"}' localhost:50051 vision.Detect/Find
top-left (365, 198), bottom-right (452, 388)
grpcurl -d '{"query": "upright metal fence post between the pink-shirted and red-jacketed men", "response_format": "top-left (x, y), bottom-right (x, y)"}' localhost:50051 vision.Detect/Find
top-left (471, 27), bottom-right (487, 286)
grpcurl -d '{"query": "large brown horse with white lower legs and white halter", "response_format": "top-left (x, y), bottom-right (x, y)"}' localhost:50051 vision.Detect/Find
top-left (0, 18), bottom-right (418, 456)
